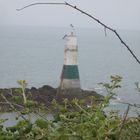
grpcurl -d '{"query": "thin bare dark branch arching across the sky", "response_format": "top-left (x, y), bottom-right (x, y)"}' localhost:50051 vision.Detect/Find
top-left (17, 2), bottom-right (140, 64)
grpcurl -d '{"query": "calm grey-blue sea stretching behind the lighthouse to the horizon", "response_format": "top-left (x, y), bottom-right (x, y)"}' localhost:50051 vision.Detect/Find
top-left (0, 26), bottom-right (140, 116)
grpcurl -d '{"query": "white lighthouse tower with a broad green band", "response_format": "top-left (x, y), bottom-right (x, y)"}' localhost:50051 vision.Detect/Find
top-left (60, 32), bottom-right (80, 90)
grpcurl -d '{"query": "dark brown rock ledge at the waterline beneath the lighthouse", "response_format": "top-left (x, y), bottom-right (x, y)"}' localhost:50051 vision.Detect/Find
top-left (0, 85), bottom-right (103, 112)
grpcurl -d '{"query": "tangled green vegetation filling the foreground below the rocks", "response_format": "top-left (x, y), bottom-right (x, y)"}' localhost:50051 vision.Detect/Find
top-left (0, 75), bottom-right (140, 140)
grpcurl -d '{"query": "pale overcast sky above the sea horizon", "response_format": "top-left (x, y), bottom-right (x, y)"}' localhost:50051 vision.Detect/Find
top-left (0, 0), bottom-right (140, 30)
